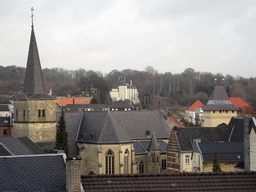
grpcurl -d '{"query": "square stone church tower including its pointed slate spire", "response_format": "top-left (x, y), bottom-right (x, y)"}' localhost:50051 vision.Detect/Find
top-left (13, 24), bottom-right (56, 142)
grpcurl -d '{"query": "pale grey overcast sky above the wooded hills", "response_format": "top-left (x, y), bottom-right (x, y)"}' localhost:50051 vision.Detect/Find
top-left (0, 0), bottom-right (256, 78)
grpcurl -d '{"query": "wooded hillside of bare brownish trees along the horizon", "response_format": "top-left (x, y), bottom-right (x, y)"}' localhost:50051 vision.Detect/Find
top-left (0, 66), bottom-right (256, 108)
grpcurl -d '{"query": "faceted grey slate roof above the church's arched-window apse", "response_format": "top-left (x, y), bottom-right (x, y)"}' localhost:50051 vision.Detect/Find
top-left (78, 112), bottom-right (131, 143)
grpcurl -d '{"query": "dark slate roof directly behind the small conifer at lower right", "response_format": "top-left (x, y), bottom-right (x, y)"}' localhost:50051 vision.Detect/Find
top-left (198, 142), bottom-right (244, 162)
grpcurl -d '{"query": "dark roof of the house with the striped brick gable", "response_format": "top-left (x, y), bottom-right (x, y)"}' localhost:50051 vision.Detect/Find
top-left (177, 127), bottom-right (232, 151)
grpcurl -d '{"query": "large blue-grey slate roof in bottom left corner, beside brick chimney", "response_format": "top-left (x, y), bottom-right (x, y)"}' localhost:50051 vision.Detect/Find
top-left (0, 154), bottom-right (66, 191)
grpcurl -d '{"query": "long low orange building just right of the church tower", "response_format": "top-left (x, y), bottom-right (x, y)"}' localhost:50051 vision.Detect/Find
top-left (56, 97), bottom-right (92, 106)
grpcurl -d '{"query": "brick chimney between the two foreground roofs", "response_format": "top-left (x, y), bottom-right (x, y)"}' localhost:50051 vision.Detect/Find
top-left (66, 158), bottom-right (82, 192)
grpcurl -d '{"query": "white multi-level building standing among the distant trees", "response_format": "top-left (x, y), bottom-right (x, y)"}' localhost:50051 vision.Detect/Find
top-left (110, 81), bottom-right (140, 104)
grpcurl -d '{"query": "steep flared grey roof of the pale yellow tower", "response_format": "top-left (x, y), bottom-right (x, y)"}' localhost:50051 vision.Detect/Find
top-left (203, 86), bottom-right (238, 111)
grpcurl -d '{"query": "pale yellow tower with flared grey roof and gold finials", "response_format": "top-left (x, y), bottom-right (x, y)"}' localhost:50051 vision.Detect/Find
top-left (203, 86), bottom-right (238, 127)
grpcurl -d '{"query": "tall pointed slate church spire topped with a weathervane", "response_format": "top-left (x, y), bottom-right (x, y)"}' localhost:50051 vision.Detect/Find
top-left (23, 8), bottom-right (45, 95)
